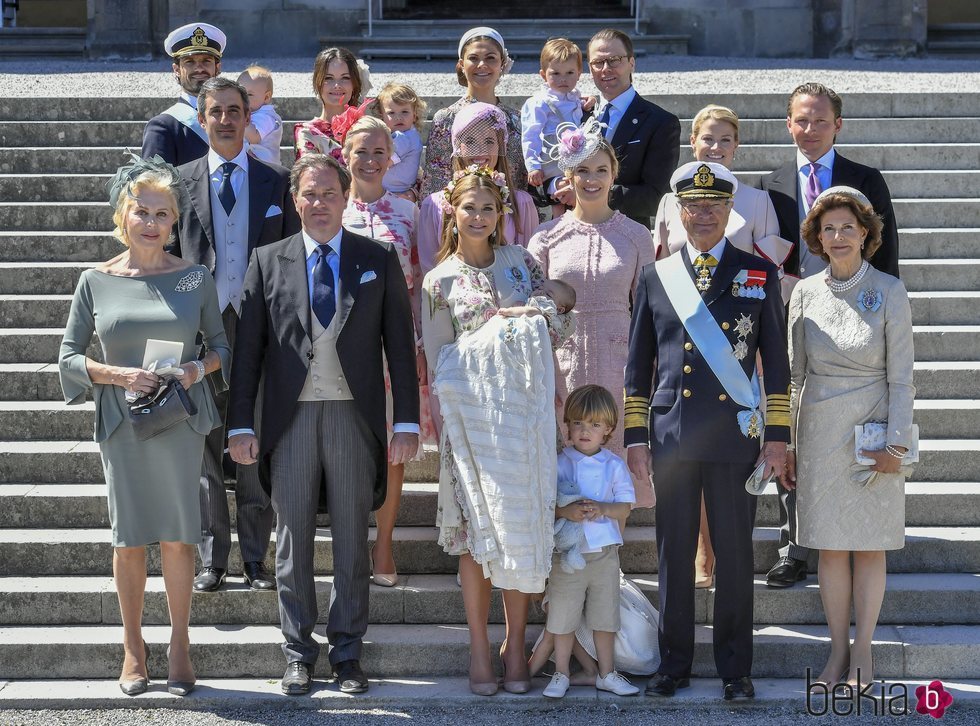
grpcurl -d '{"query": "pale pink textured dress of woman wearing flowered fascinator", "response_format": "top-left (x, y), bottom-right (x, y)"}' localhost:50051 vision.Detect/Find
top-left (528, 212), bottom-right (654, 507)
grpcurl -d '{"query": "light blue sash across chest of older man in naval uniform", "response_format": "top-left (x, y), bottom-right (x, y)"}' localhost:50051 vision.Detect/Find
top-left (656, 250), bottom-right (762, 438)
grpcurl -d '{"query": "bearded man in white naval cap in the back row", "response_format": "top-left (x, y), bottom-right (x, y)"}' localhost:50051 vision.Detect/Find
top-left (141, 23), bottom-right (226, 166)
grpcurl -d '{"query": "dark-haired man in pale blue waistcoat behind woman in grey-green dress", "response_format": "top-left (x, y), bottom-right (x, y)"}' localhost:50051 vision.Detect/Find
top-left (173, 78), bottom-right (300, 592)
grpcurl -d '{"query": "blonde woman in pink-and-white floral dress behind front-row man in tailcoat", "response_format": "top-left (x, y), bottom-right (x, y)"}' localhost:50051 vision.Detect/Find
top-left (343, 116), bottom-right (436, 587)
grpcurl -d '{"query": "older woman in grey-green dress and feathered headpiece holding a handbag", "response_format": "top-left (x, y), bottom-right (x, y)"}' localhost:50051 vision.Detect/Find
top-left (59, 157), bottom-right (231, 695)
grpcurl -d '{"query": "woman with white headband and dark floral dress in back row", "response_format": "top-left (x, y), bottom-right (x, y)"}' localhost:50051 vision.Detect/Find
top-left (422, 27), bottom-right (527, 197)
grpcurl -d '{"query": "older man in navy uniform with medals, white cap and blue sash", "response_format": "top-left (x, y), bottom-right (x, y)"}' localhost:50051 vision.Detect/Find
top-left (624, 162), bottom-right (789, 700)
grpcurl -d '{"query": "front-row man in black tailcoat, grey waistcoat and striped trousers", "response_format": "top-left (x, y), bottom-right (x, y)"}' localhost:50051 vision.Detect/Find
top-left (228, 154), bottom-right (419, 695)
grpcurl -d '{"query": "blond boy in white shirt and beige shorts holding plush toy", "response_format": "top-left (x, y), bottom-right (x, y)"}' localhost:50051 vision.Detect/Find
top-left (543, 385), bottom-right (640, 698)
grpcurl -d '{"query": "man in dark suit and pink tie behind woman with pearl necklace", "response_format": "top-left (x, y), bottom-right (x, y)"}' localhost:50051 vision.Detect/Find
top-left (762, 83), bottom-right (898, 587)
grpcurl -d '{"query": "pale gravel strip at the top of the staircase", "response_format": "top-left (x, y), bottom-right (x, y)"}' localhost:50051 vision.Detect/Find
top-left (0, 56), bottom-right (980, 97)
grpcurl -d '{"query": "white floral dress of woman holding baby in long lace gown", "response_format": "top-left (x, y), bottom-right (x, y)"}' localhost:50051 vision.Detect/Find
top-left (421, 245), bottom-right (575, 555)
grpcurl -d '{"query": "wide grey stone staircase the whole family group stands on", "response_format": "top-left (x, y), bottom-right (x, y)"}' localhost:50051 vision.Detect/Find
top-left (0, 92), bottom-right (980, 684)
